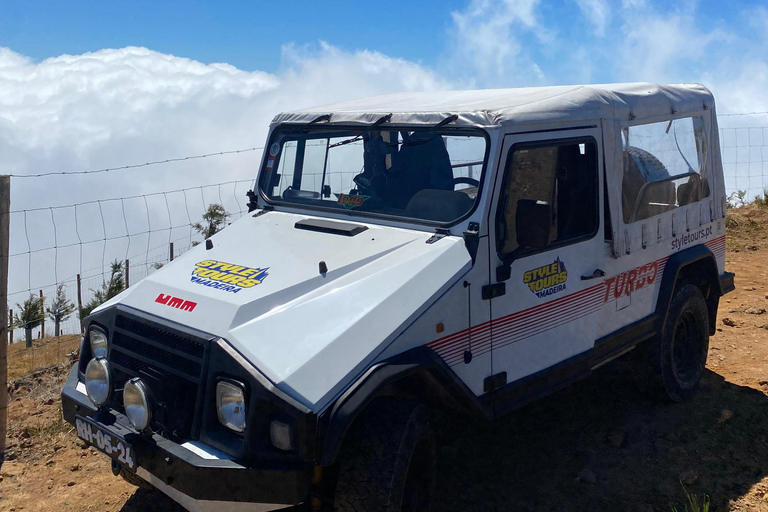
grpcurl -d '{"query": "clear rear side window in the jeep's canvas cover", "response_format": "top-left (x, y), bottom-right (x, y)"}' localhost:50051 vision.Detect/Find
top-left (621, 117), bottom-right (709, 224)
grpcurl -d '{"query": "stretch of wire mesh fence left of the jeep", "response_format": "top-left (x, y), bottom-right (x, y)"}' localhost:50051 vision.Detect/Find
top-left (8, 180), bottom-right (253, 341)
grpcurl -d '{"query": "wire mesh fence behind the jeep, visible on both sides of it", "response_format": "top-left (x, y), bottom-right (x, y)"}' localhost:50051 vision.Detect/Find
top-left (8, 114), bottom-right (768, 354)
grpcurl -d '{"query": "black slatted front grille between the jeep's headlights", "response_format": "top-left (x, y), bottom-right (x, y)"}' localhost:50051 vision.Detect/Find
top-left (109, 311), bottom-right (210, 440)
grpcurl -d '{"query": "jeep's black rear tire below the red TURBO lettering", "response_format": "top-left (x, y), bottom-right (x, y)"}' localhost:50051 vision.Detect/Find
top-left (641, 284), bottom-right (709, 402)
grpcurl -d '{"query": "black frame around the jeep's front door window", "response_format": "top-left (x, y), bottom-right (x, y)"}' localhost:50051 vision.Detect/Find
top-left (493, 135), bottom-right (602, 263)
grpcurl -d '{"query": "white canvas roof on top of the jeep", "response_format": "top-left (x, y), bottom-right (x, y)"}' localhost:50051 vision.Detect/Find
top-left (272, 83), bottom-right (714, 127)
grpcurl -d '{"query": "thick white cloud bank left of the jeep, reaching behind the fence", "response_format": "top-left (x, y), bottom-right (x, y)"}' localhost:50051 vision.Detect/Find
top-left (0, 43), bottom-right (449, 308)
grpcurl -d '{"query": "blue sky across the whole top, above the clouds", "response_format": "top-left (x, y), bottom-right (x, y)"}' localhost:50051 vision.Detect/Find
top-left (0, 0), bottom-right (766, 87)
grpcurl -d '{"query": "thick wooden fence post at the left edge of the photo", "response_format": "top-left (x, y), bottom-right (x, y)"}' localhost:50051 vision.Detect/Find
top-left (0, 175), bottom-right (11, 467)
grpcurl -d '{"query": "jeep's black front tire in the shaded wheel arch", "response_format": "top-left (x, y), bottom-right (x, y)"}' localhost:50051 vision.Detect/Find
top-left (334, 397), bottom-right (436, 512)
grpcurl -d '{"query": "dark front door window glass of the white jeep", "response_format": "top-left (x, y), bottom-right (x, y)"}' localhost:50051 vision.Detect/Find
top-left (496, 139), bottom-right (599, 254)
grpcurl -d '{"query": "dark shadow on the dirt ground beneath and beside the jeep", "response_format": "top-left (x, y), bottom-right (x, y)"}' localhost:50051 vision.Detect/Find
top-left (122, 365), bottom-right (768, 512)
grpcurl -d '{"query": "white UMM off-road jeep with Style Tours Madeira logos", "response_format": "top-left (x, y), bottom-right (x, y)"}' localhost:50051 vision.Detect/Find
top-left (62, 84), bottom-right (733, 511)
